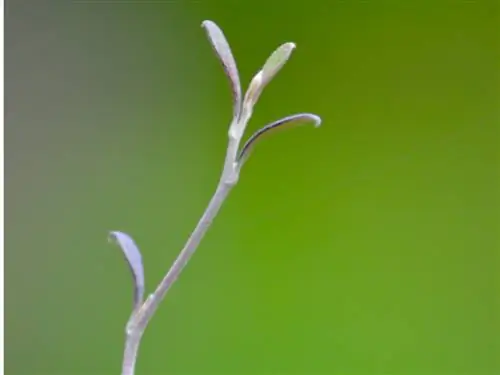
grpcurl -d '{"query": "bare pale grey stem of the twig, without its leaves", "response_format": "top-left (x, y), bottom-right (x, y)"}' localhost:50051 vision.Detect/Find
top-left (122, 130), bottom-right (241, 375)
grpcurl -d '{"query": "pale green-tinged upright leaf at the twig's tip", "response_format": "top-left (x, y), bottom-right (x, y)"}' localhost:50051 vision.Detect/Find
top-left (244, 42), bottom-right (296, 108)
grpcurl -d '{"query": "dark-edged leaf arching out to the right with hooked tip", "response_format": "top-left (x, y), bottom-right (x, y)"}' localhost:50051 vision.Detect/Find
top-left (237, 113), bottom-right (321, 168)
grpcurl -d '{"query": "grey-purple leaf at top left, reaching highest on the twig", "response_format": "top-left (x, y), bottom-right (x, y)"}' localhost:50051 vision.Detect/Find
top-left (201, 20), bottom-right (242, 119)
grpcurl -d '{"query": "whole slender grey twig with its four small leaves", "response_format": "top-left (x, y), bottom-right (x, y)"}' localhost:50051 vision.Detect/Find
top-left (111, 21), bottom-right (321, 375)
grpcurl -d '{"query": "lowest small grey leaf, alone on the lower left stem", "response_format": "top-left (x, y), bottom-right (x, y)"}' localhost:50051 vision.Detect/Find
top-left (109, 231), bottom-right (144, 311)
